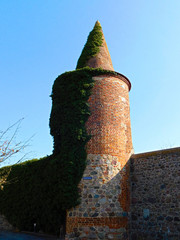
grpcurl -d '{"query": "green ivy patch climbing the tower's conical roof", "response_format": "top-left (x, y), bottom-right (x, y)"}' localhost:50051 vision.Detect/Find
top-left (76, 21), bottom-right (103, 69)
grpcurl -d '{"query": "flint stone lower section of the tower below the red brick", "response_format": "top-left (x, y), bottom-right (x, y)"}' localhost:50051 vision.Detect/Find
top-left (66, 154), bottom-right (129, 240)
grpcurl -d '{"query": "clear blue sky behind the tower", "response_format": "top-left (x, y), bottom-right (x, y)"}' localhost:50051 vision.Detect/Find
top-left (0, 0), bottom-right (180, 165)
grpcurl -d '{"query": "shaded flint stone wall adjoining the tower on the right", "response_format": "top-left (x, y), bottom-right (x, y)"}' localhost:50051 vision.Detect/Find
top-left (130, 148), bottom-right (180, 240)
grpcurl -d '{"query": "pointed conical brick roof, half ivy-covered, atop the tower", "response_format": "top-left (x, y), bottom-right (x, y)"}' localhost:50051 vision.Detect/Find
top-left (76, 21), bottom-right (114, 71)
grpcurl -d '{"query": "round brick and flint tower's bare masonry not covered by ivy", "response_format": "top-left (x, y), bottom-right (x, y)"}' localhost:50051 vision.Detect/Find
top-left (66, 22), bottom-right (132, 240)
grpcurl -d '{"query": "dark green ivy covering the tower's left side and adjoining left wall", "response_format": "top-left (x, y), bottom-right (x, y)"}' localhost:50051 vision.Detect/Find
top-left (0, 67), bottom-right (116, 233)
